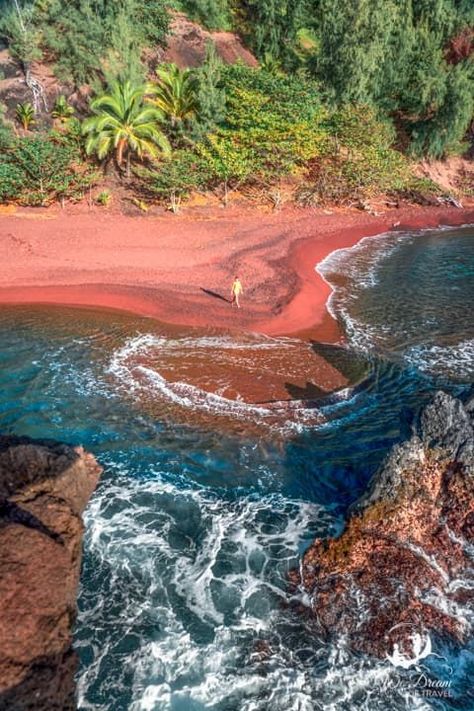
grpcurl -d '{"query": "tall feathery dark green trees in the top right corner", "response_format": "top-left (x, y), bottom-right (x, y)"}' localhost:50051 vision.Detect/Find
top-left (309, 0), bottom-right (474, 157)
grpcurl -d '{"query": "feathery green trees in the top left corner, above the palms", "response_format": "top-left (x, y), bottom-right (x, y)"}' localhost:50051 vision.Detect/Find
top-left (0, 0), bottom-right (169, 85)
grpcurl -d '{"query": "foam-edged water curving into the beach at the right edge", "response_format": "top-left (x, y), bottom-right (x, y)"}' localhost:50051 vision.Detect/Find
top-left (316, 226), bottom-right (474, 382)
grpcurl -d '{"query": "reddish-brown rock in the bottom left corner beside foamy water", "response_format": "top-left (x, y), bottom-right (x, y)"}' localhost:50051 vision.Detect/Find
top-left (0, 436), bottom-right (101, 711)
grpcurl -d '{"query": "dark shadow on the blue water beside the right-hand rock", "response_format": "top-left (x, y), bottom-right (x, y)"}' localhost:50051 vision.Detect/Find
top-left (285, 344), bottom-right (469, 516)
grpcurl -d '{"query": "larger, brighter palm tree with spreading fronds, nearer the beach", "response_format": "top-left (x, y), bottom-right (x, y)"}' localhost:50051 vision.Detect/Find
top-left (82, 80), bottom-right (171, 177)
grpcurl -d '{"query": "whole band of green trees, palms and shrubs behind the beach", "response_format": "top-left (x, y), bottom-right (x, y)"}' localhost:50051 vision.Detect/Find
top-left (0, 0), bottom-right (474, 211)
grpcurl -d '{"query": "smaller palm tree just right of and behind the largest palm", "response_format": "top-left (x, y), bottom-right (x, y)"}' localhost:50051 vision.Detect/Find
top-left (148, 64), bottom-right (198, 129)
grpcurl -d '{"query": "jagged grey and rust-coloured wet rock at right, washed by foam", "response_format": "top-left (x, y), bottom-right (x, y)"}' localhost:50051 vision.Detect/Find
top-left (290, 392), bottom-right (474, 657)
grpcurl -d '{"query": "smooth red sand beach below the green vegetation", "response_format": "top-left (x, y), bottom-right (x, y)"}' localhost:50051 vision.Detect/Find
top-left (0, 207), bottom-right (474, 341)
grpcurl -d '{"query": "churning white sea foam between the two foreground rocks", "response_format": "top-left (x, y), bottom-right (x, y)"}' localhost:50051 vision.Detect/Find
top-left (76, 475), bottom-right (434, 711)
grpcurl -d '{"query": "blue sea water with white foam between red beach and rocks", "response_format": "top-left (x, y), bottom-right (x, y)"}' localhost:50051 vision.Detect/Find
top-left (0, 228), bottom-right (474, 711)
